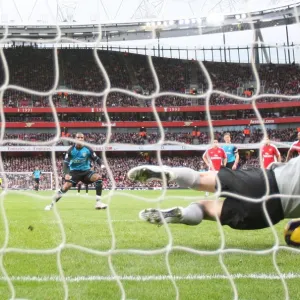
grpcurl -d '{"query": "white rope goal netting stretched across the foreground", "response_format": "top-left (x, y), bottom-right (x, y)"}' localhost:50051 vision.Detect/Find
top-left (0, 1), bottom-right (299, 299)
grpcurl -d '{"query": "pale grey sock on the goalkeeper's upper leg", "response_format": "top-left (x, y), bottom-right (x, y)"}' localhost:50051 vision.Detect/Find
top-left (172, 167), bottom-right (200, 189)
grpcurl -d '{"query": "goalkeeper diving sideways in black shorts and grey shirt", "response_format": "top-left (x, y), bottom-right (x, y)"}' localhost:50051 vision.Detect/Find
top-left (128, 156), bottom-right (300, 230)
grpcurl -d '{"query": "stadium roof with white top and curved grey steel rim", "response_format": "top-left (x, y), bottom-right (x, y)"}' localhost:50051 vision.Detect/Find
top-left (0, 0), bottom-right (300, 43)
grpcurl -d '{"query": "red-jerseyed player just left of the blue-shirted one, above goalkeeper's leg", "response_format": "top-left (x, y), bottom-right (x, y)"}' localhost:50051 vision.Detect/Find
top-left (202, 140), bottom-right (227, 171)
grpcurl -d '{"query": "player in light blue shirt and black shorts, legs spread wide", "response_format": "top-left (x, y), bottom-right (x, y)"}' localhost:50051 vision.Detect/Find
top-left (45, 132), bottom-right (107, 210)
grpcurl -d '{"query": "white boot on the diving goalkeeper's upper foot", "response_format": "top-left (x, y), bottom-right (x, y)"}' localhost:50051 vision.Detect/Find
top-left (127, 165), bottom-right (176, 182)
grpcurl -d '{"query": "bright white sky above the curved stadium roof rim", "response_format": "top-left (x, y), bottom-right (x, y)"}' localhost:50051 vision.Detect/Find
top-left (0, 0), bottom-right (300, 25)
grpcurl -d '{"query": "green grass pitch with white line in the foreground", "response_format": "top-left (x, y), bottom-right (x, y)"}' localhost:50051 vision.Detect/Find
top-left (0, 190), bottom-right (300, 300)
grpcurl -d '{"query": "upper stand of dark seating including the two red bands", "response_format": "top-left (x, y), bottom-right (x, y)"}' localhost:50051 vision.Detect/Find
top-left (0, 47), bottom-right (300, 128)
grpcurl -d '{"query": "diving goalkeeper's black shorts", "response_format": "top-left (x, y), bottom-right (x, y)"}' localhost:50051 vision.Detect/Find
top-left (218, 167), bottom-right (284, 230)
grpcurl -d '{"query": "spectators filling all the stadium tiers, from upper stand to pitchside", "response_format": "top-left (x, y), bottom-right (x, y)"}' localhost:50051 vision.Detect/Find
top-left (0, 47), bottom-right (300, 188)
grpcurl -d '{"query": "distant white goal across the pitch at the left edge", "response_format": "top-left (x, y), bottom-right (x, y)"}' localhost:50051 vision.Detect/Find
top-left (0, 172), bottom-right (53, 190)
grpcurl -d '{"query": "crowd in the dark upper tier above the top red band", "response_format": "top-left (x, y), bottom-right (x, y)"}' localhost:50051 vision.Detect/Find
top-left (0, 47), bottom-right (300, 107)
